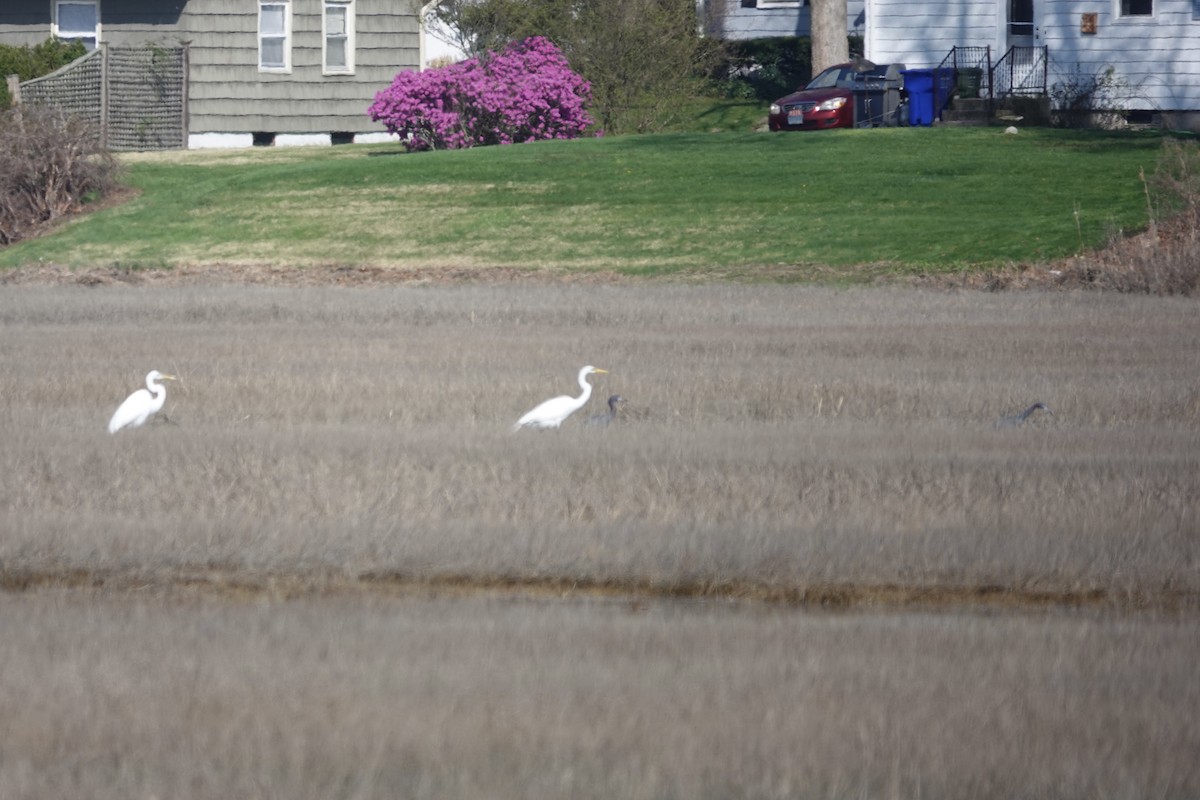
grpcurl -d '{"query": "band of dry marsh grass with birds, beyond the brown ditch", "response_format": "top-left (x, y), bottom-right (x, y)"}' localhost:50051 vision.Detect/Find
top-left (0, 287), bottom-right (1200, 604)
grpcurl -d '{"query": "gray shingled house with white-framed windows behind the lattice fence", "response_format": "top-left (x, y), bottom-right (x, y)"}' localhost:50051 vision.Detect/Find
top-left (0, 0), bottom-right (424, 146)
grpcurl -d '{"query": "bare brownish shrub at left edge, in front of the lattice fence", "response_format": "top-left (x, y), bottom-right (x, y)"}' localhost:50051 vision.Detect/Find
top-left (0, 106), bottom-right (116, 245)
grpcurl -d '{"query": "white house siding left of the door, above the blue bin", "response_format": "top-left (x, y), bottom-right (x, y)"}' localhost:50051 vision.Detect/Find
top-left (864, 0), bottom-right (1003, 68)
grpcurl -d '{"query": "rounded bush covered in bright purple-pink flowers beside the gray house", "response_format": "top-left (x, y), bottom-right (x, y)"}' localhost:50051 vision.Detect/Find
top-left (367, 36), bottom-right (592, 151)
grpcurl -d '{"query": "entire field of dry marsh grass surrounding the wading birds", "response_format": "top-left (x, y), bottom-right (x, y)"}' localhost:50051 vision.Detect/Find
top-left (0, 283), bottom-right (1200, 800)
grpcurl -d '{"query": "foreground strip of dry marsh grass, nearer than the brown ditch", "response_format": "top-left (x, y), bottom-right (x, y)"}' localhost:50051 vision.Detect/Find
top-left (0, 591), bottom-right (1200, 800)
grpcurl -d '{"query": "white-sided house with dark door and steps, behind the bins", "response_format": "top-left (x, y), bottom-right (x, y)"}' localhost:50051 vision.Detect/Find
top-left (864, 0), bottom-right (1200, 130)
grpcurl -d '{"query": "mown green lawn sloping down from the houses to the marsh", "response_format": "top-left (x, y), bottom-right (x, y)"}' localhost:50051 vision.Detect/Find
top-left (0, 123), bottom-right (1163, 279)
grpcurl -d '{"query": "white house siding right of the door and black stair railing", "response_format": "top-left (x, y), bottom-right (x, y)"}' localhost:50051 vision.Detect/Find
top-left (1034, 0), bottom-right (1200, 112)
